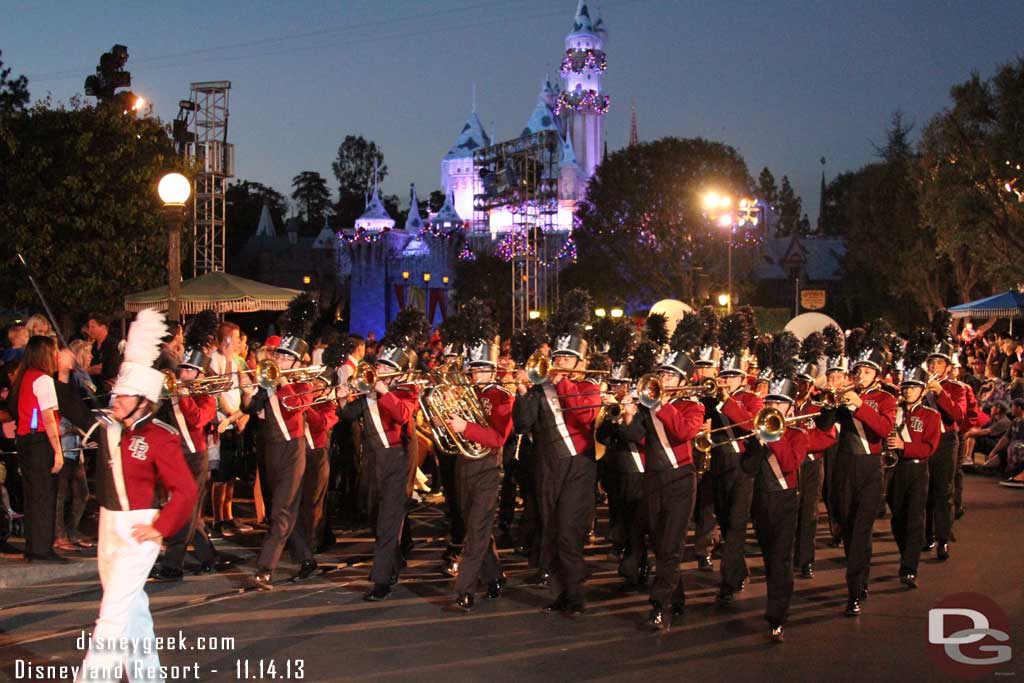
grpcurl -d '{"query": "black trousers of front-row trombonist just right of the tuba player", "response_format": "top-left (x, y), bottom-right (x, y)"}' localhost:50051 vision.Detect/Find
top-left (541, 453), bottom-right (597, 602)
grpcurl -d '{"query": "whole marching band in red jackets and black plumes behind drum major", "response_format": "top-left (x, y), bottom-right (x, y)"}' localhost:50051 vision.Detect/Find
top-left (64, 291), bottom-right (970, 642)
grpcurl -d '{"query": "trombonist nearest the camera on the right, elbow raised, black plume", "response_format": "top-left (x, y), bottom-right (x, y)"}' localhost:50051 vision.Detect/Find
top-left (743, 342), bottom-right (836, 643)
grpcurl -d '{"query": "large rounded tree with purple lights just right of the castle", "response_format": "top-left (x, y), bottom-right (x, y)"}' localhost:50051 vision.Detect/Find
top-left (562, 137), bottom-right (753, 304)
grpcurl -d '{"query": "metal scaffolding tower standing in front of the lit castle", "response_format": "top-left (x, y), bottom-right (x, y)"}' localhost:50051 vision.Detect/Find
top-left (473, 130), bottom-right (559, 333)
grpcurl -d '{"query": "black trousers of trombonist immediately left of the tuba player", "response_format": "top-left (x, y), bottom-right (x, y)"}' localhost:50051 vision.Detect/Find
top-left (370, 445), bottom-right (409, 584)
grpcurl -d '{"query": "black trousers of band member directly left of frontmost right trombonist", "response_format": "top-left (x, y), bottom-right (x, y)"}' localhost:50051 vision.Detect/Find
top-left (712, 466), bottom-right (754, 593)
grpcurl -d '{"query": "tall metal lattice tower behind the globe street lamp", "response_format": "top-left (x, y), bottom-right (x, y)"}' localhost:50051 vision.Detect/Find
top-left (187, 81), bottom-right (234, 276)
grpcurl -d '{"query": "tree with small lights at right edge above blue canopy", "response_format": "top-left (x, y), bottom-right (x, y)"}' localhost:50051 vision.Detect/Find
top-left (919, 57), bottom-right (1024, 301)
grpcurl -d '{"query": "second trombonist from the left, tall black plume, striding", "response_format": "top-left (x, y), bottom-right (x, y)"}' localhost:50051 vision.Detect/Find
top-left (243, 294), bottom-right (316, 591)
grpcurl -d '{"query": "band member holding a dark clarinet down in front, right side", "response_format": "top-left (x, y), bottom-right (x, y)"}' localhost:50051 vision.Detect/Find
top-left (886, 367), bottom-right (942, 588)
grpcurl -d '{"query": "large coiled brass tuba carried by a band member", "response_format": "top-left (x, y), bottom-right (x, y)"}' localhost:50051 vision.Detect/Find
top-left (419, 365), bottom-right (490, 460)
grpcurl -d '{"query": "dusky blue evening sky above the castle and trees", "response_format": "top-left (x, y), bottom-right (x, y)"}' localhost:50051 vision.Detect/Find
top-left (0, 0), bottom-right (1022, 227)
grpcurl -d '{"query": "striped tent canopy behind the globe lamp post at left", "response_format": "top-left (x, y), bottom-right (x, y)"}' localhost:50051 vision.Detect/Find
top-left (125, 272), bottom-right (300, 315)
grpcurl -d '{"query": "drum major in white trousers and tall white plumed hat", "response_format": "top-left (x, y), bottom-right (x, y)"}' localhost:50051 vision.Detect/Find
top-left (79, 309), bottom-right (197, 681)
